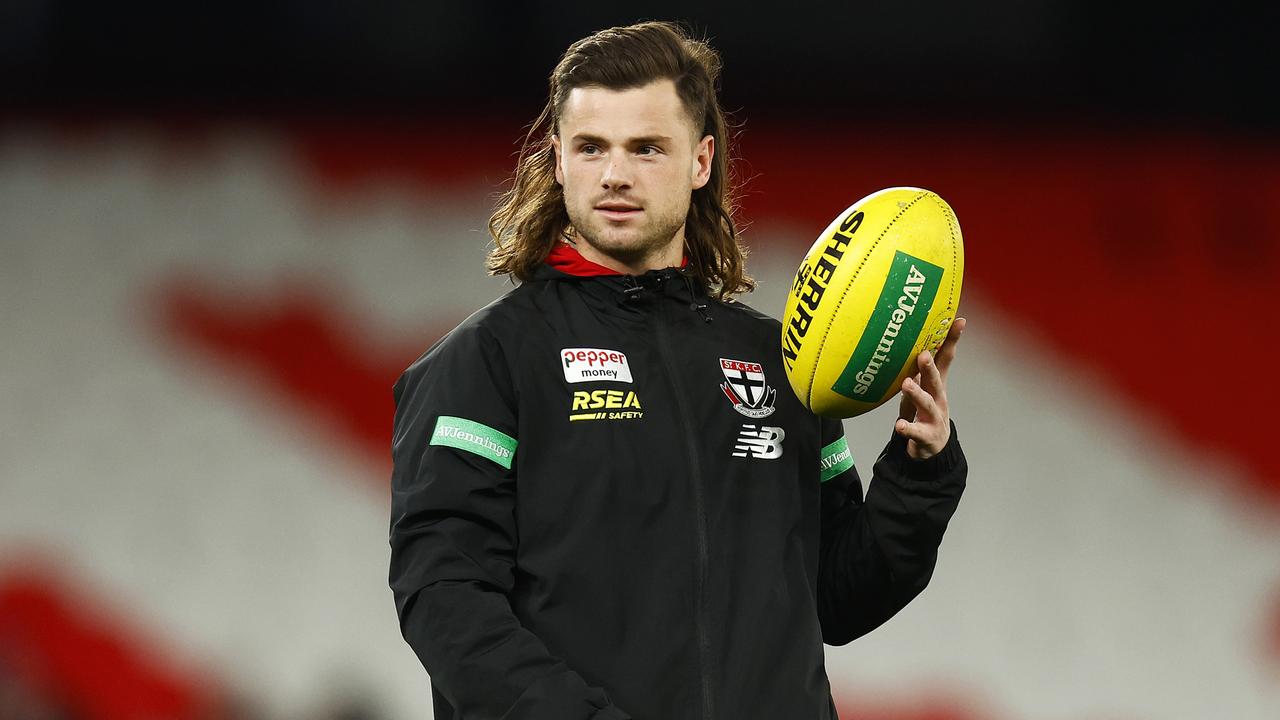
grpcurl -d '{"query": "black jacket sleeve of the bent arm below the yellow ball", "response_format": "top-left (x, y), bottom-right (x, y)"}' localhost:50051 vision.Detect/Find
top-left (818, 420), bottom-right (969, 646)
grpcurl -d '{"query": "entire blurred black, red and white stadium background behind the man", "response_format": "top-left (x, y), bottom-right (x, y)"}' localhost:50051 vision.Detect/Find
top-left (0, 0), bottom-right (1280, 720)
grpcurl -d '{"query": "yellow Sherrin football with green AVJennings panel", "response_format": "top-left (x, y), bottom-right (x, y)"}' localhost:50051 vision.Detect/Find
top-left (782, 187), bottom-right (964, 418)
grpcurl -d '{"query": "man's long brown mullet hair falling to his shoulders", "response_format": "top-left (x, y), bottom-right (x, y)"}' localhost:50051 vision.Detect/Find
top-left (485, 22), bottom-right (755, 299)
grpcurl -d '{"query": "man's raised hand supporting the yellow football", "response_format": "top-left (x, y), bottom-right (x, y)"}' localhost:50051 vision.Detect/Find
top-left (893, 318), bottom-right (968, 460)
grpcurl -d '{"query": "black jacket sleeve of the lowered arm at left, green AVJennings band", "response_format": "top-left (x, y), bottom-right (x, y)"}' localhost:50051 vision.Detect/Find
top-left (389, 324), bottom-right (630, 720)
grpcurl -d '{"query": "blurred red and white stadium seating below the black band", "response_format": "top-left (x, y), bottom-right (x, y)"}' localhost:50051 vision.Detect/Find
top-left (0, 123), bottom-right (1280, 720)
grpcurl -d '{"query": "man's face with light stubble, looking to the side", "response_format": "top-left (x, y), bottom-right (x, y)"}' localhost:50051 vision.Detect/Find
top-left (552, 79), bottom-right (714, 268)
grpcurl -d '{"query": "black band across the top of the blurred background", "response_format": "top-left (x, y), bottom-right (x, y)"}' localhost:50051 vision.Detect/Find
top-left (0, 0), bottom-right (1280, 135)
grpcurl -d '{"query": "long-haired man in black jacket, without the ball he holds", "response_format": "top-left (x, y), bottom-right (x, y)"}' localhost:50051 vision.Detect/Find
top-left (390, 23), bottom-right (966, 720)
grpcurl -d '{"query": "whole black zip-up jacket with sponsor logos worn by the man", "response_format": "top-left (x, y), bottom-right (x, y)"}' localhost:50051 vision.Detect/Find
top-left (390, 248), bottom-right (966, 720)
